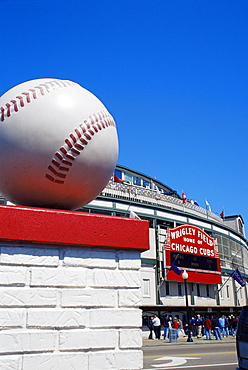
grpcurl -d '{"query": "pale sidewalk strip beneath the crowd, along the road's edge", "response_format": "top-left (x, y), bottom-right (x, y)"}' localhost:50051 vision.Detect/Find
top-left (143, 335), bottom-right (236, 347)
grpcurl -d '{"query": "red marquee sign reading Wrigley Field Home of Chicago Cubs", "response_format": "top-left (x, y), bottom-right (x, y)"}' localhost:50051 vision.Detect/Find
top-left (165, 225), bottom-right (222, 284)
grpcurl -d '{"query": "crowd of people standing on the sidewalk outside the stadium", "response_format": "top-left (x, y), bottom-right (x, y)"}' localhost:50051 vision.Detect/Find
top-left (148, 314), bottom-right (238, 340)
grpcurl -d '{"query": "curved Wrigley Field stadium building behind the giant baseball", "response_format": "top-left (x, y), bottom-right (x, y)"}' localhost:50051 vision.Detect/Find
top-left (80, 165), bottom-right (248, 325)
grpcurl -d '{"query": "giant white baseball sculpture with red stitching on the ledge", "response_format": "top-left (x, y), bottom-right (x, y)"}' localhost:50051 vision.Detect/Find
top-left (0, 78), bottom-right (118, 210)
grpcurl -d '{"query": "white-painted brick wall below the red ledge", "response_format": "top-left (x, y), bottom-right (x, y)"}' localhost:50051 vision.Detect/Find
top-left (0, 243), bottom-right (142, 370)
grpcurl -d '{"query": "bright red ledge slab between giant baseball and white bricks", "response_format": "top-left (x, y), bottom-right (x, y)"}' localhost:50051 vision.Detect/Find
top-left (0, 205), bottom-right (149, 251)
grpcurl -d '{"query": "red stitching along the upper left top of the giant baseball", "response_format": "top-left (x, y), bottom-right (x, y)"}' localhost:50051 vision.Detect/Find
top-left (0, 80), bottom-right (76, 122)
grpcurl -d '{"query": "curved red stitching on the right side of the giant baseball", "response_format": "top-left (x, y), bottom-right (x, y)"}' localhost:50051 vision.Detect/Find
top-left (46, 112), bottom-right (115, 184)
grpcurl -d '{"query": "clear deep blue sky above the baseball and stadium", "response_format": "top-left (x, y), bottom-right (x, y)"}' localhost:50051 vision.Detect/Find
top-left (0, 0), bottom-right (248, 230)
